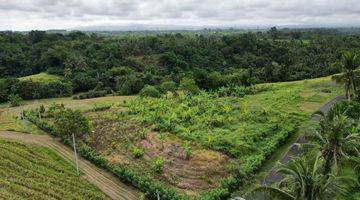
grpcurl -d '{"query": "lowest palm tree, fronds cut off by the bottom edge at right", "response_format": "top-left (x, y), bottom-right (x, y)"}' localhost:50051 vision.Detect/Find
top-left (248, 154), bottom-right (350, 200)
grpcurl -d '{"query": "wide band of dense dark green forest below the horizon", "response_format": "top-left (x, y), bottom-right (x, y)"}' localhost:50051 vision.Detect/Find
top-left (0, 27), bottom-right (360, 102)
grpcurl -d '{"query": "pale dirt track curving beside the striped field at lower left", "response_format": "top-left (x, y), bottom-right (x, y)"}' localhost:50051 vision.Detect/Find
top-left (0, 131), bottom-right (140, 200)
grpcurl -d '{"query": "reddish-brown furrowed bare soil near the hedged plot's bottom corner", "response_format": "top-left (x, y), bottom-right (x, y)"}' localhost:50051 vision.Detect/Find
top-left (138, 133), bottom-right (229, 192)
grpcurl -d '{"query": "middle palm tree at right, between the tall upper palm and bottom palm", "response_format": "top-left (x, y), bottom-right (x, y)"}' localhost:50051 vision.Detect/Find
top-left (314, 105), bottom-right (360, 174)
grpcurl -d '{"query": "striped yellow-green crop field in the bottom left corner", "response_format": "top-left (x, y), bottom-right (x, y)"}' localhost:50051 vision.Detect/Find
top-left (0, 140), bottom-right (109, 200)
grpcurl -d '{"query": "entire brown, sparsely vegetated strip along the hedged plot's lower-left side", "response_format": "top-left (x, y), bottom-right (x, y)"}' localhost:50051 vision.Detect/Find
top-left (87, 115), bottom-right (230, 195)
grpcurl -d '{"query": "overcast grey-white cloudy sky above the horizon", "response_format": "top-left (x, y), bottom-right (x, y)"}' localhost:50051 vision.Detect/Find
top-left (0, 0), bottom-right (360, 30)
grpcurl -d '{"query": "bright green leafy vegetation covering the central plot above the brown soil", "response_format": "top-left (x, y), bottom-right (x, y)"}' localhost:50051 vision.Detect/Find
top-left (127, 79), bottom-right (341, 184)
